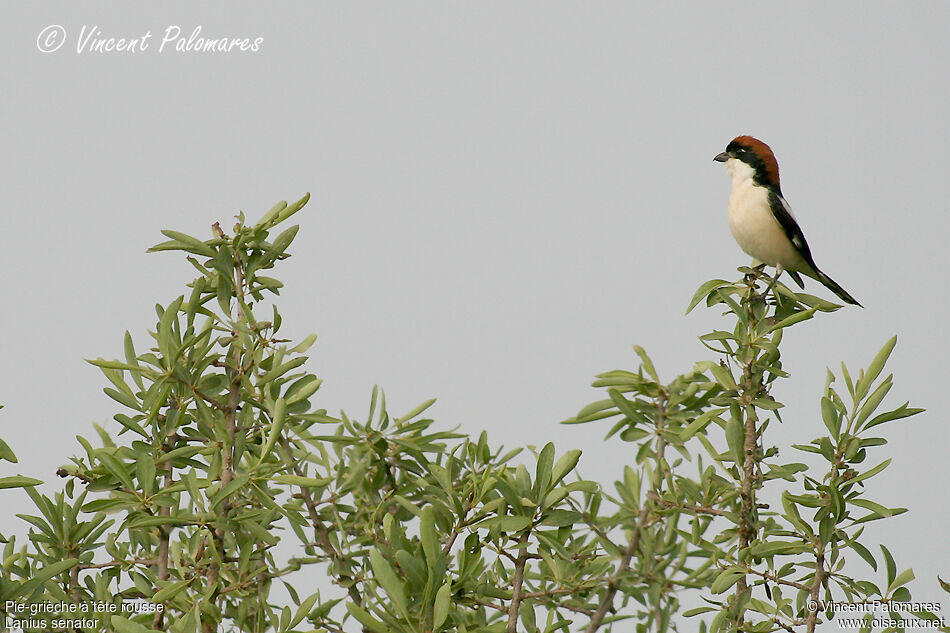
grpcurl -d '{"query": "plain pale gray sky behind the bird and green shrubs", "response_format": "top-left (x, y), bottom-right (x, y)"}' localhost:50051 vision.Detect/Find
top-left (0, 1), bottom-right (950, 614)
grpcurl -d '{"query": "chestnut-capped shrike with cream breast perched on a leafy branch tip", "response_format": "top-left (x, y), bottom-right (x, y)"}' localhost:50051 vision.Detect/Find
top-left (713, 136), bottom-right (864, 307)
